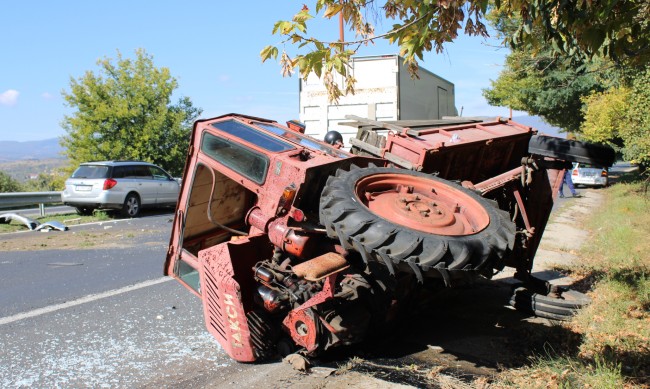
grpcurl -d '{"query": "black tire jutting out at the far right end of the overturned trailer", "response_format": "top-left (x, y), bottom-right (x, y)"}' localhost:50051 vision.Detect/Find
top-left (528, 135), bottom-right (616, 167)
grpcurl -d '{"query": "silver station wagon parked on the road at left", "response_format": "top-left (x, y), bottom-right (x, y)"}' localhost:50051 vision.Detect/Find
top-left (61, 161), bottom-right (179, 217)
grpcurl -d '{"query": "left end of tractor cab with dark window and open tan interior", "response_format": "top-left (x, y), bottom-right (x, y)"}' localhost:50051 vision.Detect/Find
top-left (165, 131), bottom-right (269, 295)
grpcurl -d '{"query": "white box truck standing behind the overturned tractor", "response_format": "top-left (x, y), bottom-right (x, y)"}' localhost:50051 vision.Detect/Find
top-left (300, 55), bottom-right (458, 148)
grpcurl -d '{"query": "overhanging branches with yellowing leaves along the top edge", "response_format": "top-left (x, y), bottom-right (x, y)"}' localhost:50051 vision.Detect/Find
top-left (260, 0), bottom-right (650, 100)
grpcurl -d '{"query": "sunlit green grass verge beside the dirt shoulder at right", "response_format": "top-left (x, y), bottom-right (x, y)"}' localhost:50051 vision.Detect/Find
top-left (494, 180), bottom-right (650, 388)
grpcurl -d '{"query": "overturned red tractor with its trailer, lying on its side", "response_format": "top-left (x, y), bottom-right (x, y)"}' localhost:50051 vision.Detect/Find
top-left (165, 114), bottom-right (613, 362)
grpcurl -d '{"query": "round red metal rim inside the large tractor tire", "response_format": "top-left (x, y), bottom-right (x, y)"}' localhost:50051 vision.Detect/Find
top-left (355, 173), bottom-right (490, 236)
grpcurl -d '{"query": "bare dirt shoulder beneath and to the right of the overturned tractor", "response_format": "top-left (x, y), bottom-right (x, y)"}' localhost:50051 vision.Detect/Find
top-left (152, 190), bottom-right (602, 388)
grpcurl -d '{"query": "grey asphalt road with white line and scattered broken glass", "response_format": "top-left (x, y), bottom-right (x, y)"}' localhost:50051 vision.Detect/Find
top-left (0, 215), bottom-right (251, 388)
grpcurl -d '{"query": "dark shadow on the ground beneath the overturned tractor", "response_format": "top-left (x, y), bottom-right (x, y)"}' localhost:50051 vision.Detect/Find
top-left (322, 280), bottom-right (579, 387)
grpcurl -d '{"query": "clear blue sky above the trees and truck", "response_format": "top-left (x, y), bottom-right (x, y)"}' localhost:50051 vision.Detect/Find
top-left (0, 0), bottom-right (508, 141)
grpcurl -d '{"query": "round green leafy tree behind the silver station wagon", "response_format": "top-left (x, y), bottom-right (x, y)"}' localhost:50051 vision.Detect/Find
top-left (61, 49), bottom-right (201, 175)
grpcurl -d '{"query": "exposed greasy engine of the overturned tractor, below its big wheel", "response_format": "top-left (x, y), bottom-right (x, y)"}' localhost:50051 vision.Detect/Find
top-left (248, 253), bottom-right (381, 354)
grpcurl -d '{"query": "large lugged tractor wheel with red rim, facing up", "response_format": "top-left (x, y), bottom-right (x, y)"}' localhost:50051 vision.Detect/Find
top-left (320, 165), bottom-right (515, 274)
